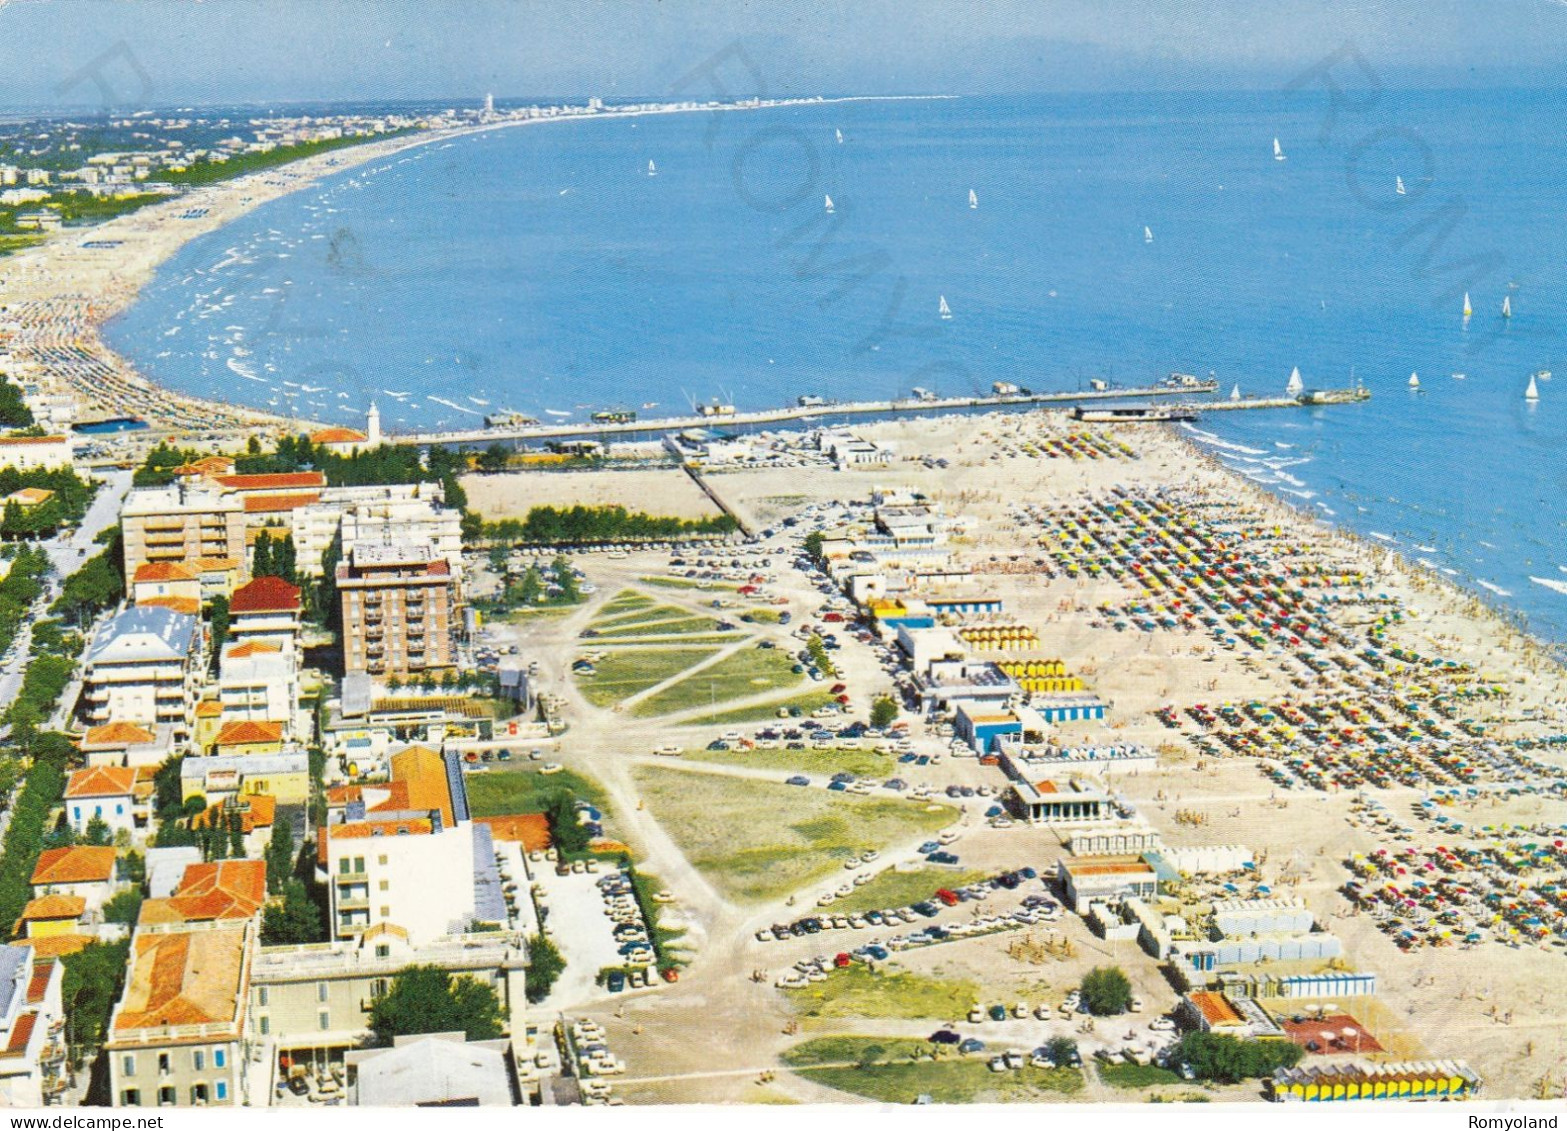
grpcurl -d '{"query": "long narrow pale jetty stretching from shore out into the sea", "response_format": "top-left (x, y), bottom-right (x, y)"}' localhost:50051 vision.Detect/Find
top-left (401, 381), bottom-right (1219, 445)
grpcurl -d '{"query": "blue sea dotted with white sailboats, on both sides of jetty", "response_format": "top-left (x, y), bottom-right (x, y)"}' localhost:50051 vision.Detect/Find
top-left (108, 88), bottom-right (1567, 642)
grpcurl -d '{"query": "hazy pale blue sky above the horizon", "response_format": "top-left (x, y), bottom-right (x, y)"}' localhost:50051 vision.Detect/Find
top-left (9, 0), bottom-right (1567, 108)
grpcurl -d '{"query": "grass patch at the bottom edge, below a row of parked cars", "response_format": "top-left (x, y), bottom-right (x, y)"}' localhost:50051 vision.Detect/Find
top-left (784, 1037), bottom-right (1083, 1103)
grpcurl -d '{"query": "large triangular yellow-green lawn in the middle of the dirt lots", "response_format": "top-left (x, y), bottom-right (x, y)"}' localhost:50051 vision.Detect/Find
top-left (633, 766), bottom-right (957, 902)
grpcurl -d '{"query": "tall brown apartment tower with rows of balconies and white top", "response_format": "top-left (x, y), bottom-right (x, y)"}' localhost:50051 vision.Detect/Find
top-left (337, 542), bottom-right (459, 678)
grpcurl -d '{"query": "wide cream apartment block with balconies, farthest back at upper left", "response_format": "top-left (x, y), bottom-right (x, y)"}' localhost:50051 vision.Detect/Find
top-left (121, 481), bottom-right (244, 578)
